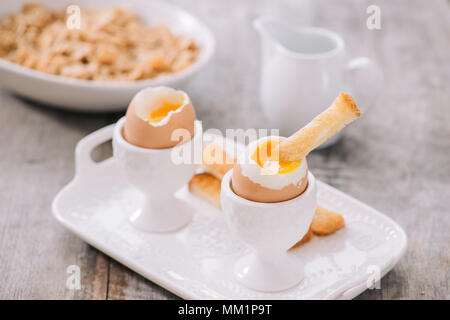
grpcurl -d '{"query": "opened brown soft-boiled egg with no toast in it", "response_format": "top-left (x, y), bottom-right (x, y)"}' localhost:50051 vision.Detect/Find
top-left (123, 87), bottom-right (195, 149)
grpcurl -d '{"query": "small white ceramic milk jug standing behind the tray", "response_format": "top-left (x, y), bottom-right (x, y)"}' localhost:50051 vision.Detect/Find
top-left (254, 17), bottom-right (382, 147)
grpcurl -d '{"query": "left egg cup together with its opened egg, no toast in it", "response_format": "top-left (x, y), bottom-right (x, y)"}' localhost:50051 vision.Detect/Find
top-left (113, 87), bottom-right (202, 232)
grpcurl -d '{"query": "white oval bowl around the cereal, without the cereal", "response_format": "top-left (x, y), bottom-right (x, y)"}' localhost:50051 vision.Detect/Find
top-left (0, 0), bottom-right (215, 111)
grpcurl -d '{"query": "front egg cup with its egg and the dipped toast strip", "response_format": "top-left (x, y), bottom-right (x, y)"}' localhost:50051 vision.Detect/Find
top-left (220, 93), bottom-right (360, 292)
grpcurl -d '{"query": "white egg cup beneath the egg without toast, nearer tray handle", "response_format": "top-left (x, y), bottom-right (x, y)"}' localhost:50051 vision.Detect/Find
top-left (113, 117), bottom-right (202, 232)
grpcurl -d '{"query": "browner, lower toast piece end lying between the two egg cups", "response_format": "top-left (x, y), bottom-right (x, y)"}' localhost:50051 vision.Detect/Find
top-left (189, 173), bottom-right (220, 209)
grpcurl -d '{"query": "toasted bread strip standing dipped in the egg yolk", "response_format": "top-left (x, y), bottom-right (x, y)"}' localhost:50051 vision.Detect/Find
top-left (279, 92), bottom-right (360, 161)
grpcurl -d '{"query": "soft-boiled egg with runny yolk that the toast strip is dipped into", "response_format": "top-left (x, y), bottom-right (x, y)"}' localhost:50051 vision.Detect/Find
top-left (231, 136), bottom-right (308, 203)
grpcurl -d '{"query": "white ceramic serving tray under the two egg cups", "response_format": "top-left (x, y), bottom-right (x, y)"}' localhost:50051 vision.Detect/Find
top-left (52, 126), bottom-right (407, 299)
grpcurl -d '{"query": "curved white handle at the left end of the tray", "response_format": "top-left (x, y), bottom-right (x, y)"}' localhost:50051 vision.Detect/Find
top-left (75, 124), bottom-right (114, 176)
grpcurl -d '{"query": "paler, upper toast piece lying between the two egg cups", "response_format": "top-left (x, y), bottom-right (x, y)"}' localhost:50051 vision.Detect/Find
top-left (202, 143), bottom-right (236, 179)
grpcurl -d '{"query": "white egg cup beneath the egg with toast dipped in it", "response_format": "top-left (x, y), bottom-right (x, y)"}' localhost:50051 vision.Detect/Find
top-left (220, 170), bottom-right (317, 292)
